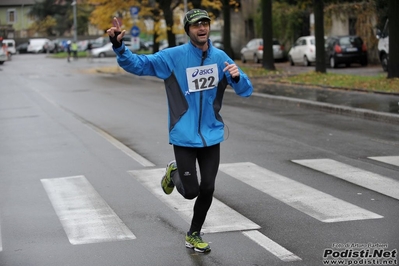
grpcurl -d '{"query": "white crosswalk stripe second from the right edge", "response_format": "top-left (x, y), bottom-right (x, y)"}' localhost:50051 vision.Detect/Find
top-left (293, 159), bottom-right (399, 199)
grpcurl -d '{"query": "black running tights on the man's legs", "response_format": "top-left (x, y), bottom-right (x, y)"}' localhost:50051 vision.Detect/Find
top-left (172, 144), bottom-right (220, 232)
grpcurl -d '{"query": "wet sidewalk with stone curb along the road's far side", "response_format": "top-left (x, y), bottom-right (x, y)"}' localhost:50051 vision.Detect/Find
top-left (95, 66), bottom-right (399, 125)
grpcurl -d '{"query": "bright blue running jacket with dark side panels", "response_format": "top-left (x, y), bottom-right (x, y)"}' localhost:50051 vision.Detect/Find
top-left (114, 40), bottom-right (253, 147)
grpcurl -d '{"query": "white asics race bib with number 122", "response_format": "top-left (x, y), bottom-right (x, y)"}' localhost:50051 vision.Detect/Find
top-left (186, 64), bottom-right (219, 92)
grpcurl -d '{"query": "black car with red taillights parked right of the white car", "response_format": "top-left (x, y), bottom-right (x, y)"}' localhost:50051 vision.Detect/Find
top-left (325, 35), bottom-right (368, 68)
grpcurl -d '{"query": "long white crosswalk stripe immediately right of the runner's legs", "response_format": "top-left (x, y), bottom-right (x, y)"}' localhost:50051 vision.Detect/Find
top-left (219, 162), bottom-right (383, 223)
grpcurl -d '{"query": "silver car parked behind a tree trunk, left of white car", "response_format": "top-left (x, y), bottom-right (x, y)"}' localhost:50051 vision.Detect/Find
top-left (240, 38), bottom-right (284, 63)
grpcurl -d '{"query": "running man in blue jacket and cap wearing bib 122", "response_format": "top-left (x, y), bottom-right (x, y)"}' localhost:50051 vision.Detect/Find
top-left (107, 9), bottom-right (253, 252)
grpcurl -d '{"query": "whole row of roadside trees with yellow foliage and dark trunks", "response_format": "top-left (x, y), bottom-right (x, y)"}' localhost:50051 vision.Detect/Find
top-left (31, 0), bottom-right (399, 78)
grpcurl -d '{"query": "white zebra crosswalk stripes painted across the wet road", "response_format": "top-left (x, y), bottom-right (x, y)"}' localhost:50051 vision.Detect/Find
top-left (0, 156), bottom-right (399, 261)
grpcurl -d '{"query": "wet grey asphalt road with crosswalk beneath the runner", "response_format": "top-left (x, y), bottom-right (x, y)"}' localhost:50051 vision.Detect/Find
top-left (0, 55), bottom-right (399, 266)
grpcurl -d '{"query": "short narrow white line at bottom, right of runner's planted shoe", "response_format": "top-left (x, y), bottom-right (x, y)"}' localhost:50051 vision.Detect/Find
top-left (242, 230), bottom-right (302, 262)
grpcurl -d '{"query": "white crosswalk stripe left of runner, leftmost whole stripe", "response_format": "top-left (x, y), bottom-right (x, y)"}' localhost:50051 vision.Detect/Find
top-left (41, 176), bottom-right (136, 245)
